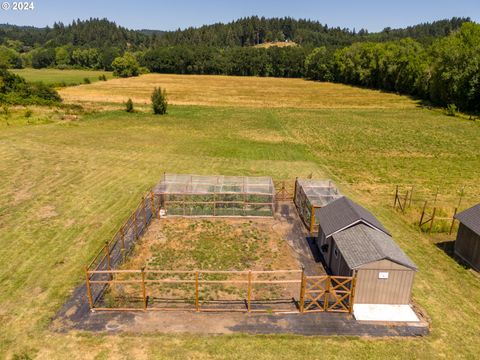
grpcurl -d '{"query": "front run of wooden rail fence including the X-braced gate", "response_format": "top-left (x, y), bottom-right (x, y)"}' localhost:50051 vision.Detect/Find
top-left (86, 269), bottom-right (356, 313)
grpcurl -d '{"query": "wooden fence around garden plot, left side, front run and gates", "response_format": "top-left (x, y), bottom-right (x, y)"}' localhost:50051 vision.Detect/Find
top-left (85, 181), bottom-right (355, 313)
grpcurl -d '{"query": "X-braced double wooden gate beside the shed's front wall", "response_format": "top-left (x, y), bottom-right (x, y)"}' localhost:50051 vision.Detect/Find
top-left (300, 275), bottom-right (356, 313)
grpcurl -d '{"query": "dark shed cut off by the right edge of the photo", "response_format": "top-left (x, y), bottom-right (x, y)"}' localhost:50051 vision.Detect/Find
top-left (455, 204), bottom-right (480, 271)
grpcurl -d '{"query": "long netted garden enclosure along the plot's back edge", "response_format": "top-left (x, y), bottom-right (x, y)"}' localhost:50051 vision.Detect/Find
top-left (153, 174), bottom-right (275, 216)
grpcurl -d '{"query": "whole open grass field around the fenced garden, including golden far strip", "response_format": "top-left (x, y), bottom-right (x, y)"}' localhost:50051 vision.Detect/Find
top-left (0, 71), bottom-right (480, 359)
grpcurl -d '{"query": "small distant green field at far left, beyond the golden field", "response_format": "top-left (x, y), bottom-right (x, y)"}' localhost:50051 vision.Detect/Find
top-left (11, 68), bottom-right (113, 85)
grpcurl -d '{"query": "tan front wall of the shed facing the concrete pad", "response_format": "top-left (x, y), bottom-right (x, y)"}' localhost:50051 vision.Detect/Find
top-left (355, 260), bottom-right (415, 305)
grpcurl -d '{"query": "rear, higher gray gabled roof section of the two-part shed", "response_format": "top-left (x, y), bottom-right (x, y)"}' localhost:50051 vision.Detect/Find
top-left (317, 196), bottom-right (390, 237)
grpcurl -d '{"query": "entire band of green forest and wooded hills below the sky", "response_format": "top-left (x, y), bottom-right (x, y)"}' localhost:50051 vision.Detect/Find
top-left (0, 17), bottom-right (480, 111)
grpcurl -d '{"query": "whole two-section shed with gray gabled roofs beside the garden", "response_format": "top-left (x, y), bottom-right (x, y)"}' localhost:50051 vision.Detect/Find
top-left (317, 197), bottom-right (417, 305)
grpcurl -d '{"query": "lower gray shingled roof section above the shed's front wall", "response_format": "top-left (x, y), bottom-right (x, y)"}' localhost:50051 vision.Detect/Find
top-left (333, 224), bottom-right (417, 270)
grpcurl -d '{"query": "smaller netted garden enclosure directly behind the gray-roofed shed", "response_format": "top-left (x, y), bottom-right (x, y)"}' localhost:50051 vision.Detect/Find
top-left (294, 179), bottom-right (343, 233)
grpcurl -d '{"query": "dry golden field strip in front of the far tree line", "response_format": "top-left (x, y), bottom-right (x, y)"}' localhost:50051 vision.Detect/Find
top-left (60, 74), bottom-right (415, 109)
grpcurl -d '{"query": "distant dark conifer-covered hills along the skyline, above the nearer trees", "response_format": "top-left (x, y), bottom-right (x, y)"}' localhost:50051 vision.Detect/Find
top-left (0, 16), bottom-right (470, 52)
